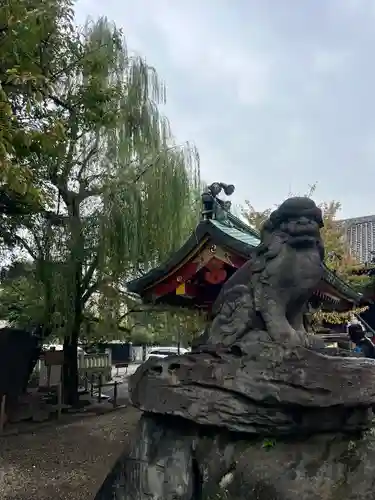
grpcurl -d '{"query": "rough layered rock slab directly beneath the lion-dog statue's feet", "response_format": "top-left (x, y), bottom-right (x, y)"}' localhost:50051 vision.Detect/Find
top-left (130, 338), bottom-right (375, 437)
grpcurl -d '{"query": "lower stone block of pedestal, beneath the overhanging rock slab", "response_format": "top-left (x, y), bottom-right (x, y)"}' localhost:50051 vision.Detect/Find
top-left (95, 416), bottom-right (375, 500)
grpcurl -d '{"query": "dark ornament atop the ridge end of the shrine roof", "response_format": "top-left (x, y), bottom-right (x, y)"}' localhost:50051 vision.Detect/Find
top-left (202, 182), bottom-right (235, 224)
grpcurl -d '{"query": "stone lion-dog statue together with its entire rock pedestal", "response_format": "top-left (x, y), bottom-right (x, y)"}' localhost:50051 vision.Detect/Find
top-left (95, 198), bottom-right (375, 500)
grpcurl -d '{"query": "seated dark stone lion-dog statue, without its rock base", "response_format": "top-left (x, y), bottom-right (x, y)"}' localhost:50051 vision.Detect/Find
top-left (205, 197), bottom-right (324, 346)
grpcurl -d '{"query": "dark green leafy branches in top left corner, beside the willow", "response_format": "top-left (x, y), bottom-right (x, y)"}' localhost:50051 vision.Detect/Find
top-left (0, 0), bottom-right (73, 202)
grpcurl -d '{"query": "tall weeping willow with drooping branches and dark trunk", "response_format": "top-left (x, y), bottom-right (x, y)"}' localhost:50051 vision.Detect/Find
top-left (2, 15), bottom-right (199, 403)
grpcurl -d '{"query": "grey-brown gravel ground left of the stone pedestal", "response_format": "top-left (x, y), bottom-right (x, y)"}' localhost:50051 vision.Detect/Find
top-left (0, 408), bottom-right (139, 500)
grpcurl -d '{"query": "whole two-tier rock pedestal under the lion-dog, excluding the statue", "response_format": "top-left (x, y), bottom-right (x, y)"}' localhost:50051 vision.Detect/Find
top-left (96, 340), bottom-right (375, 500)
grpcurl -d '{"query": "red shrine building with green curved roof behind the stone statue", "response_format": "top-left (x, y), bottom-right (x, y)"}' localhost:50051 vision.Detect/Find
top-left (127, 183), bottom-right (362, 320)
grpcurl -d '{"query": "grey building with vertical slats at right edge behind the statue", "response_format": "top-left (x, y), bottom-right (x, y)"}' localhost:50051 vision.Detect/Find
top-left (340, 215), bottom-right (375, 264)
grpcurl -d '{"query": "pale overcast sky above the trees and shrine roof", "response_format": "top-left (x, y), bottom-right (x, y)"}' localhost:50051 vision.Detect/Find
top-left (76, 0), bottom-right (375, 217)
